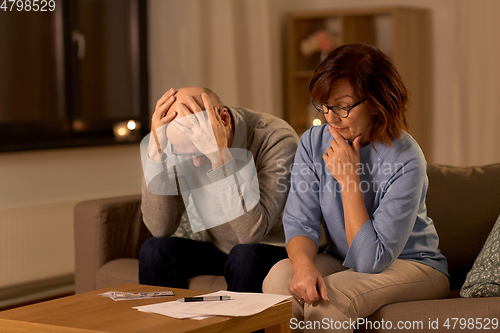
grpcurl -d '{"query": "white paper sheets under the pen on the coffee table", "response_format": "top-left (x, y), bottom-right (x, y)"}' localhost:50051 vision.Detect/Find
top-left (134, 290), bottom-right (291, 319)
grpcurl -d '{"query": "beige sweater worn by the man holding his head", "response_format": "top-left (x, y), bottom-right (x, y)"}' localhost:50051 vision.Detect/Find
top-left (141, 108), bottom-right (298, 253)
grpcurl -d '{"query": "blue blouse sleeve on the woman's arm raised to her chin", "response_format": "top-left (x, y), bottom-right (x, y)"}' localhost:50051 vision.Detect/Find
top-left (343, 158), bottom-right (427, 273)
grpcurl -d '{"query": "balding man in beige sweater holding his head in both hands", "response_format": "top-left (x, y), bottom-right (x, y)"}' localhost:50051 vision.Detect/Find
top-left (139, 87), bottom-right (298, 292)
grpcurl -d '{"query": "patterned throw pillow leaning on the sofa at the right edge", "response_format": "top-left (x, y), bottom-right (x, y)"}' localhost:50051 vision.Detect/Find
top-left (460, 216), bottom-right (500, 297)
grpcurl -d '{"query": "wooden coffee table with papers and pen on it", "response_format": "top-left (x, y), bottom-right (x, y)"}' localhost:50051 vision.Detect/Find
top-left (0, 284), bottom-right (292, 333)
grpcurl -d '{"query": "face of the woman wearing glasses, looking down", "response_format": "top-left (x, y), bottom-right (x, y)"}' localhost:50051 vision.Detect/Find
top-left (325, 81), bottom-right (372, 145)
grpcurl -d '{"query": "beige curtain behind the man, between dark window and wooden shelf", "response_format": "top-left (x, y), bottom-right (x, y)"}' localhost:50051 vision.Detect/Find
top-left (148, 0), bottom-right (285, 116)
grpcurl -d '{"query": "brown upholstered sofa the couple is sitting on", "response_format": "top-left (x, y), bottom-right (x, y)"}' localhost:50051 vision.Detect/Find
top-left (74, 164), bottom-right (500, 332)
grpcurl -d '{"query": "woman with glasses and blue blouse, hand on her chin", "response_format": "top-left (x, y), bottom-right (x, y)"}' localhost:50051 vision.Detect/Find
top-left (263, 44), bottom-right (449, 332)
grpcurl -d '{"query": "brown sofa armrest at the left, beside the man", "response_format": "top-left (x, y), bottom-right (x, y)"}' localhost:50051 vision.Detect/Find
top-left (74, 195), bottom-right (151, 293)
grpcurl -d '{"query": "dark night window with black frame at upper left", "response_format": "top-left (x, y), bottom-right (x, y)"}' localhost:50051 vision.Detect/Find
top-left (0, 0), bottom-right (149, 151)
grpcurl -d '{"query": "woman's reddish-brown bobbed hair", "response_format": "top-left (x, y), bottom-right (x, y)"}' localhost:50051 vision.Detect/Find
top-left (309, 44), bottom-right (408, 145)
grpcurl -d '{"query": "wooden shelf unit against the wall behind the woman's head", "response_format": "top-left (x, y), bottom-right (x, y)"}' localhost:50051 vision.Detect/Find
top-left (284, 7), bottom-right (432, 156)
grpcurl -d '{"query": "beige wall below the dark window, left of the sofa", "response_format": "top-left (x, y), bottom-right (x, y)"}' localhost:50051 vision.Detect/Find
top-left (0, 144), bottom-right (142, 288)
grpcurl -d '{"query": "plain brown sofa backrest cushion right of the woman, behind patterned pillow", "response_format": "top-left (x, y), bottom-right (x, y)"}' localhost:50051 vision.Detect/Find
top-left (426, 163), bottom-right (500, 289)
